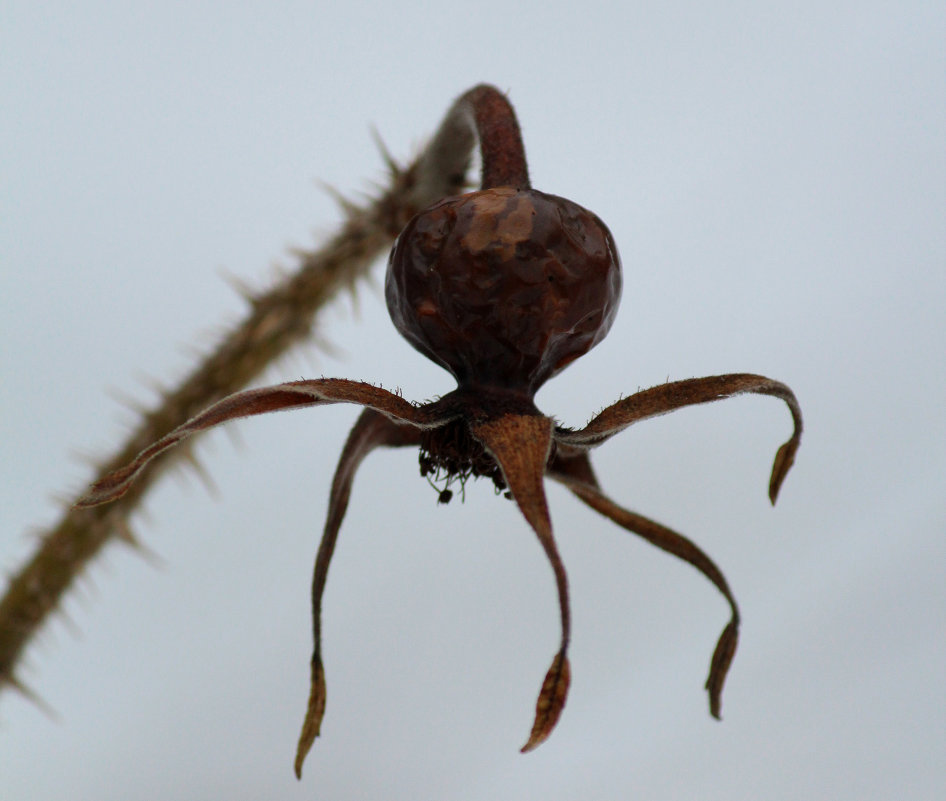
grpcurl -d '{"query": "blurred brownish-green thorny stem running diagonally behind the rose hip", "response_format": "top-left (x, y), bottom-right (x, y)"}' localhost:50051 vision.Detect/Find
top-left (0, 90), bottom-right (478, 690)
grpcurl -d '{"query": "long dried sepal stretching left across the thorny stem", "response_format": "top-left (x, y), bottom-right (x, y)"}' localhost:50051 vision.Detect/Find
top-left (75, 378), bottom-right (429, 509)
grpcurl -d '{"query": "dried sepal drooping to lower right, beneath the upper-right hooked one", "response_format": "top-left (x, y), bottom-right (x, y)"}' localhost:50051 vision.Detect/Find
top-left (549, 449), bottom-right (739, 719)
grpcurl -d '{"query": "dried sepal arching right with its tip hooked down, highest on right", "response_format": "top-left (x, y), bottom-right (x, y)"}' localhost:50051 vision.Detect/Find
top-left (555, 373), bottom-right (802, 503)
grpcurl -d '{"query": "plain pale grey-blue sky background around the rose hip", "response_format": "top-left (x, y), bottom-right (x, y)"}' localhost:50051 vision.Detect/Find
top-left (0, 0), bottom-right (946, 801)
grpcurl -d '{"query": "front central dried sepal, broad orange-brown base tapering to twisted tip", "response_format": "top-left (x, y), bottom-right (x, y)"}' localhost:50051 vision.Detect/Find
top-left (470, 414), bottom-right (571, 751)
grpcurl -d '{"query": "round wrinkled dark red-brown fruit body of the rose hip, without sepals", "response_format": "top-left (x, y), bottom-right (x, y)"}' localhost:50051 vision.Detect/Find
top-left (385, 186), bottom-right (621, 397)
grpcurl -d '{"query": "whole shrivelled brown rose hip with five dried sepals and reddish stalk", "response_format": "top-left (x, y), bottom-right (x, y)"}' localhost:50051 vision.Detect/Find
top-left (70, 85), bottom-right (802, 777)
